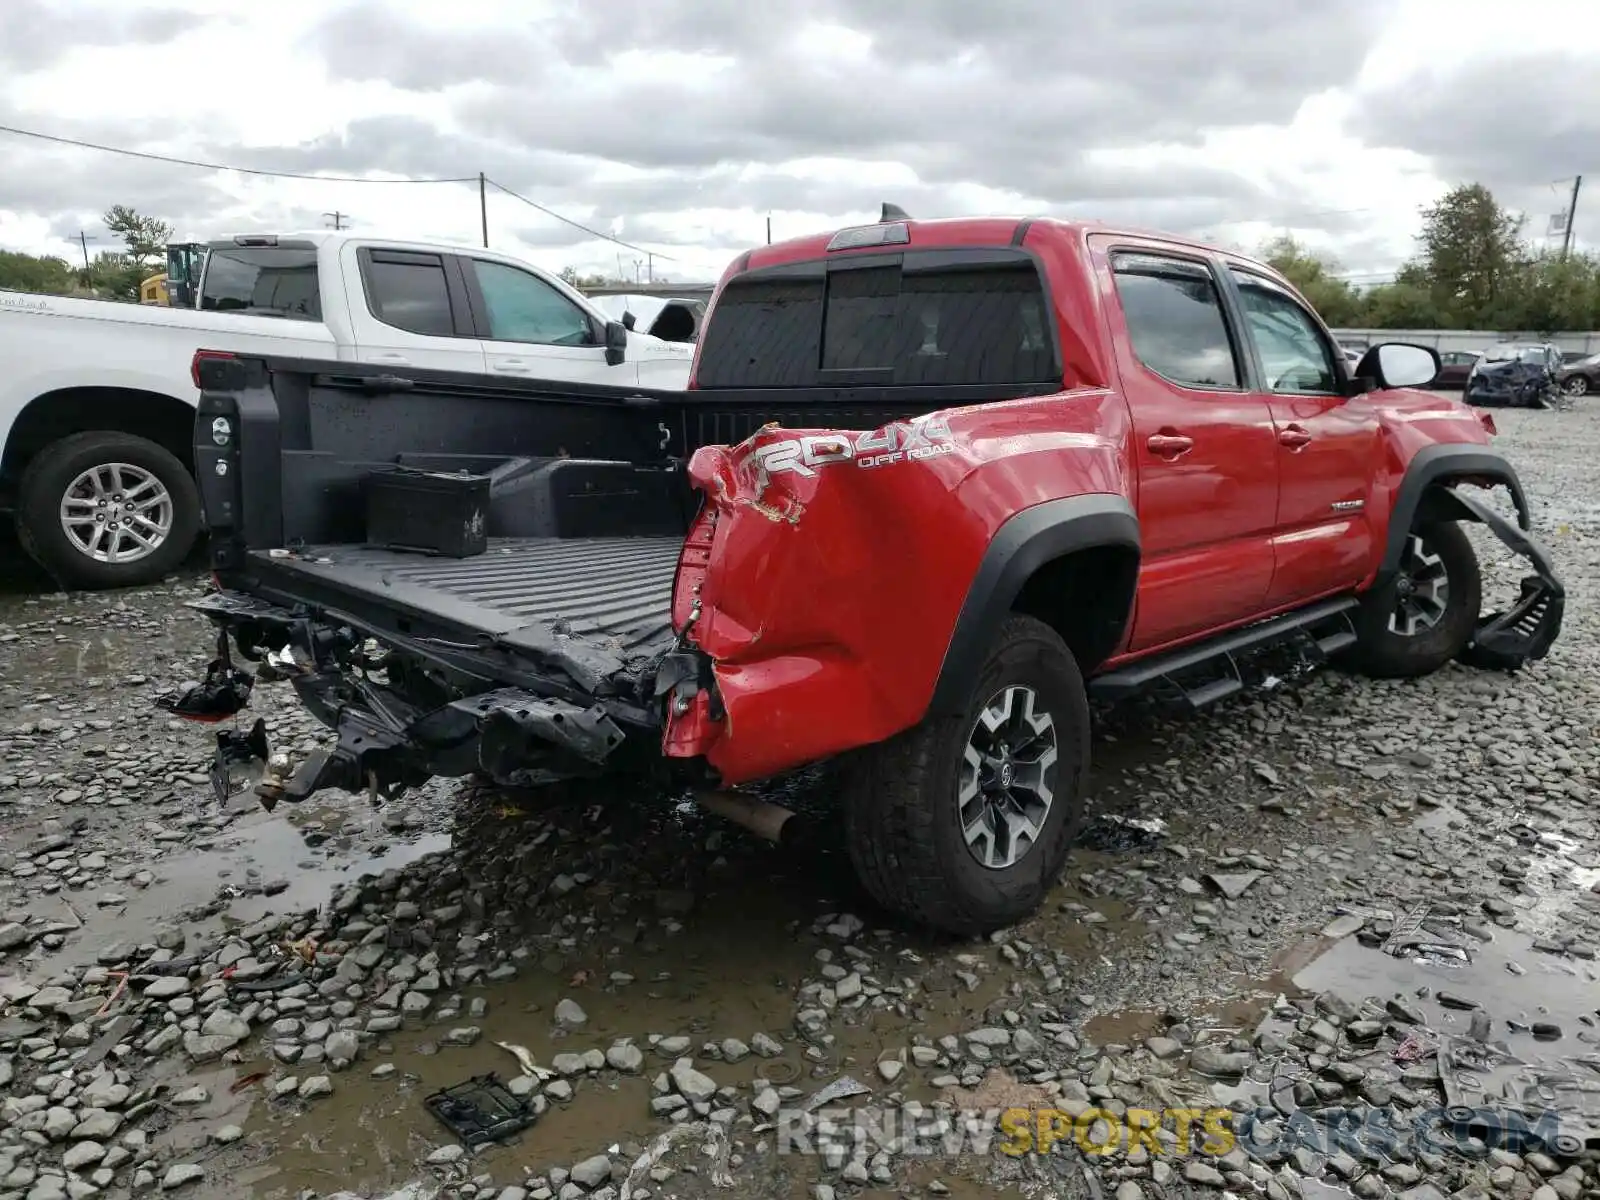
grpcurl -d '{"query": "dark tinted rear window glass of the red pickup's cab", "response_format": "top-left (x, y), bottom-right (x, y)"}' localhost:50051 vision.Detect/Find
top-left (698, 256), bottom-right (1061, 387)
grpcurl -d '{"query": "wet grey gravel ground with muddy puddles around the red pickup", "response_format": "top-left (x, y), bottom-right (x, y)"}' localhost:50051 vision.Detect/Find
top-left (0, 405), bottom-right (1600, 1200)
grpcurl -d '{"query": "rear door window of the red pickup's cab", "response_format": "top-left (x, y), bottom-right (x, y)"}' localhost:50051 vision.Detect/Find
top-left (1112, 254), bottom-right (1242, 390)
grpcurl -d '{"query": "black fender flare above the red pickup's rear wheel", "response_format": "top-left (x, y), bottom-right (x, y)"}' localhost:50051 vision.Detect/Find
top-left (926, 493), bottom-right (1139, 717)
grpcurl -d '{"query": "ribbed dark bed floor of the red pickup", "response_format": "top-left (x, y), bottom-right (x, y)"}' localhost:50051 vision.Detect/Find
top-left (251, 538), bottom-right (683, 658)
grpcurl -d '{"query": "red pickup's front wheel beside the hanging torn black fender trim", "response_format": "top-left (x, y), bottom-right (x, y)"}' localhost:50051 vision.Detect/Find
top-left (1350, 522), bottom-right (1483, 678)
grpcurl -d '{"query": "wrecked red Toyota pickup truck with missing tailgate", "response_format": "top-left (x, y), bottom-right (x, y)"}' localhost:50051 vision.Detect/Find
top-left (178, 211), bottom-right (1563, 933)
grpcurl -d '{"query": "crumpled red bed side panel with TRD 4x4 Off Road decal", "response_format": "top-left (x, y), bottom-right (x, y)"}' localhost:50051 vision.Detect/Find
top-left (662, 389), bottom-right (1130, 784)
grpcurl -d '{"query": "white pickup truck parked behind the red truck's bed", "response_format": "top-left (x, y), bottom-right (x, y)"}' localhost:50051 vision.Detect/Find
top-left (0, 230), bottom-right (694, 587)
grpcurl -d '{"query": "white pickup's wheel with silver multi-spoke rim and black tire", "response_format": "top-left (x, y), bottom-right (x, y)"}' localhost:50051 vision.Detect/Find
top-left (16, 430), bottom-right (200, 589)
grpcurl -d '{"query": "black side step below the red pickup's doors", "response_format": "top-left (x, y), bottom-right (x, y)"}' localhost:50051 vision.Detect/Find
top-left (1088, 595), bottom-right (1360, 709)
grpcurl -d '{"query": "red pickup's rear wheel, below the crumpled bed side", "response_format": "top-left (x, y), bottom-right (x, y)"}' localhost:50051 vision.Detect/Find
top-left (845, 616), bottom-right (1090, 936)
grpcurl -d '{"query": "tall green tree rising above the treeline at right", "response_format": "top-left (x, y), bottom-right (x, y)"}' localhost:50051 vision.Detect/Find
top-left (1416, 184), bottom-right (1528, 328)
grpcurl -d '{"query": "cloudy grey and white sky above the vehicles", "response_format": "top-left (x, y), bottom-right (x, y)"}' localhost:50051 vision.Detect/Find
top-left (0, 0), bottom-right (1600, 280)
